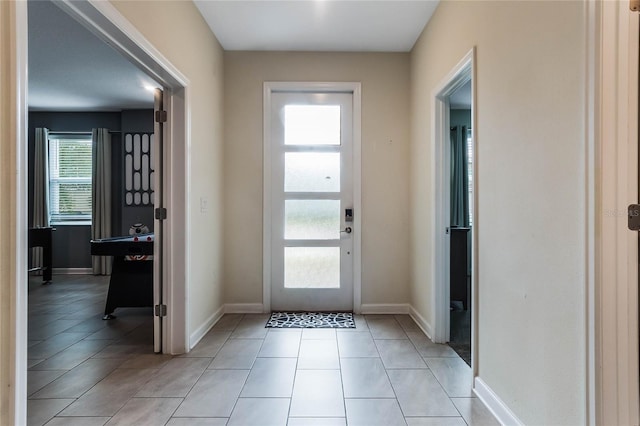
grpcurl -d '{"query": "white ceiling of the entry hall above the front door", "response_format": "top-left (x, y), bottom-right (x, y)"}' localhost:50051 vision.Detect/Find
top-left (194, 0), bottom-right (439, 52)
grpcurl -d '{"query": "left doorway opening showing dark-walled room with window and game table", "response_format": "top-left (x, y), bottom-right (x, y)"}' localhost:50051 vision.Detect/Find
top-left (27, 1), bottom-right (163, 360)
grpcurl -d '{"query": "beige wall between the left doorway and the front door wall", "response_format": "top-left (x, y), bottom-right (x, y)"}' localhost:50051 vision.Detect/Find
top-left (113, 1), bottom-right (224, 340)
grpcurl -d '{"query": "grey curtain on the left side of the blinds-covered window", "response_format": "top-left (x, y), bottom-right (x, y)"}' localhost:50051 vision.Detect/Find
top-left (31, 127), bottom-right (49, 273)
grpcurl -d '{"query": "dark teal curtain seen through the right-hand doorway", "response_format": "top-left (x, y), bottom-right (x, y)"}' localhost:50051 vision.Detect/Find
top-left (451, 126), bottom-right (469, 227)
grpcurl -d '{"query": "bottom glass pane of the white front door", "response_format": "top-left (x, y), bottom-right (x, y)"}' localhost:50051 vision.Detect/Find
top-left (284, 247), bottom-right (340, 288)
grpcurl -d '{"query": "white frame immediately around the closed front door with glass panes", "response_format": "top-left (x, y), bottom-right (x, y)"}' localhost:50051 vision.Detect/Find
top-left (262, 81), bottom-right (362, 313)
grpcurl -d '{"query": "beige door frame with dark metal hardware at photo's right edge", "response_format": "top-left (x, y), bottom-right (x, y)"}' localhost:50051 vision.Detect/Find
top-left (596, 1), bottom-right (640, 425)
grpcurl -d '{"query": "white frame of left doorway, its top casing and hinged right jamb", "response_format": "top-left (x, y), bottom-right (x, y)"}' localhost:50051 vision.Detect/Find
top-left (38, 0), bottom-right (188, 353)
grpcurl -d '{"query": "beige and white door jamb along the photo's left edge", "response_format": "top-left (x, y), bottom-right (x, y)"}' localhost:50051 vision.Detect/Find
top-left (6, 2), bottom-right (28, 424)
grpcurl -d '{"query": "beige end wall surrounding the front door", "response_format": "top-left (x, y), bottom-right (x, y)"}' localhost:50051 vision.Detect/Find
top-left (224, 52), bottom-right (409, 304)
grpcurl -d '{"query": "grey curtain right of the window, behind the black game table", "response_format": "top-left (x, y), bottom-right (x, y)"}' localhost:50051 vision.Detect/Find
top-left (91, 129), bottom-right (111, 275)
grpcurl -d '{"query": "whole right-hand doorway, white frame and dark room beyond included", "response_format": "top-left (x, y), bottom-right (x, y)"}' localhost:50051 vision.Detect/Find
top-left (433, 49), bottom-right (478, 370)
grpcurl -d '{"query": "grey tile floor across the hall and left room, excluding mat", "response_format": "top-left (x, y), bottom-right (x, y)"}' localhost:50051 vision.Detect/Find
top-left (27, 275), bottom-right (498, 426)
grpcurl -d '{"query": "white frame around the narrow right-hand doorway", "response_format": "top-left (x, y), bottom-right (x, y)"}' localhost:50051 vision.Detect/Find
top-left (431, 47), bottom-right (478, 362)
